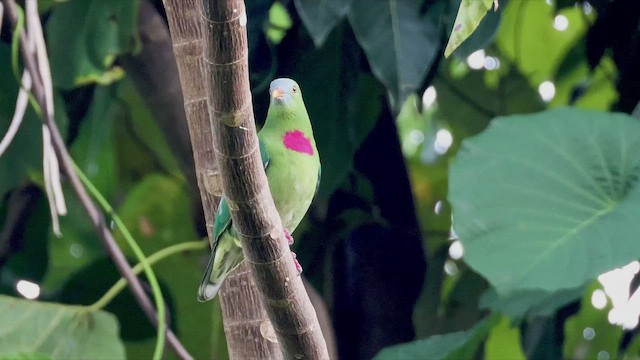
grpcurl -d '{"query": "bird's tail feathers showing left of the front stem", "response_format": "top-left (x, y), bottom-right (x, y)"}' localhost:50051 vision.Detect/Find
top-left (198, 234), bottom-right (244, 302)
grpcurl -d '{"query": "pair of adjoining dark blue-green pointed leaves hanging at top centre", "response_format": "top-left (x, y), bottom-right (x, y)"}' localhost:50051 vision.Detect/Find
top-left (295, 0), bottom-right (440, 110)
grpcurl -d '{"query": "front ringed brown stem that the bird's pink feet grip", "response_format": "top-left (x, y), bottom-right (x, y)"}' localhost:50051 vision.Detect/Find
top-left (202, 0), bottom-right (329, 359)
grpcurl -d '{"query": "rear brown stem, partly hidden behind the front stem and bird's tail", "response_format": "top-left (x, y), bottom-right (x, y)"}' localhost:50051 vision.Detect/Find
top-left (156, 0), bottom-right (282, 359)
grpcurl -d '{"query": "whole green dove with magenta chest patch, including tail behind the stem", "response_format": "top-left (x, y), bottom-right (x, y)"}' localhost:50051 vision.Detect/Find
top-left (198, 78), bottom-right (320, 301)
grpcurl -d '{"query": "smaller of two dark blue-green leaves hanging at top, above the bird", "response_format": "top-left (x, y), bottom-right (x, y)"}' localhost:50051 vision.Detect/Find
top-left (294, 0), bottom-right (351, 47)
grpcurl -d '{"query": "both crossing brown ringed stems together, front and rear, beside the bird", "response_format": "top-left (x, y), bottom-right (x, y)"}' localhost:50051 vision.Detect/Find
top-left (164, 0), bottom-right (328, 359)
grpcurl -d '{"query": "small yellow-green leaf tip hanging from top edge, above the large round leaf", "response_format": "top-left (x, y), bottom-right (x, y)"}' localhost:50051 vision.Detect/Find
top-left (444, 0), bottom-right (493, 57)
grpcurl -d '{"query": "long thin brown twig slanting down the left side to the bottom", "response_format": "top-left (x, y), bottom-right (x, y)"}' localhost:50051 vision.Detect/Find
top-left (2, 0), bottom-right (193, 359)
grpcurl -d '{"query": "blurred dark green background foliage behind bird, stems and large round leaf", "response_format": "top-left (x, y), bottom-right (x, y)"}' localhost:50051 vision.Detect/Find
top-left (0, 0), bottom-right (640, 359)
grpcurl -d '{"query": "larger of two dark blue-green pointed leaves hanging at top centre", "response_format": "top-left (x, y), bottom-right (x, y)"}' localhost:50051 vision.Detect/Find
top-left (348, 0), bottom-right (439, 112)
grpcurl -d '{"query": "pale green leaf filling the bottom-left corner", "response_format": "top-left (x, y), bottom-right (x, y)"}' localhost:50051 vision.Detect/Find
top-left (0, 295), bottom-right (125, 359)
